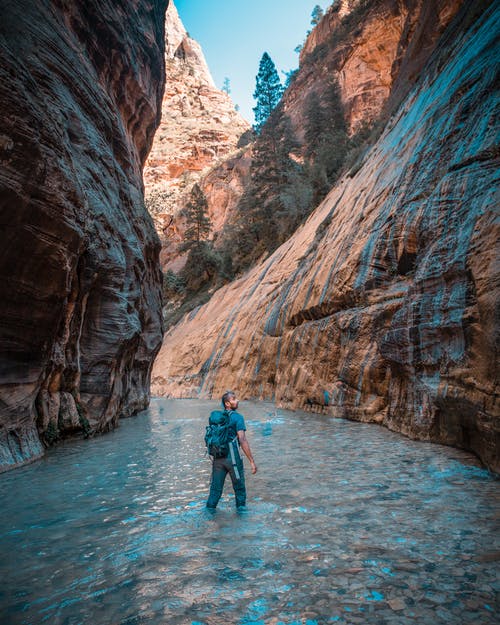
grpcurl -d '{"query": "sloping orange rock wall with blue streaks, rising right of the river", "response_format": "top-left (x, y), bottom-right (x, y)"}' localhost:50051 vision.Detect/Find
top-left (152, 4), bottom-right (500, 471)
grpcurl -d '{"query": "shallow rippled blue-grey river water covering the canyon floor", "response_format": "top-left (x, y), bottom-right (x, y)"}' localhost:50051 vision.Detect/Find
top-left (0, 400), bottom-right (500, 625)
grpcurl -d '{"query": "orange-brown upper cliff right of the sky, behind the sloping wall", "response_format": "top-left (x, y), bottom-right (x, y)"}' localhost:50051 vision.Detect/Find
top-left (290, 0), bottom-right (463, 134)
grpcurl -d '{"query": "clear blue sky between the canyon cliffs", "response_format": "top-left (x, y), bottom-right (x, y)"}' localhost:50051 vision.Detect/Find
top-left (174, 0), bottom-right (330, 123)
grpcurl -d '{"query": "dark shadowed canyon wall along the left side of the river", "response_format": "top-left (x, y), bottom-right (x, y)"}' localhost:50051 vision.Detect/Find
top-left (0, 0), bottom-right (166, 470)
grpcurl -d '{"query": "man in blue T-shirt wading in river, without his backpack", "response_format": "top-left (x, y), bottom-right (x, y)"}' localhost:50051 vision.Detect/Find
top-left (207, 391), bottom-right (257, 510)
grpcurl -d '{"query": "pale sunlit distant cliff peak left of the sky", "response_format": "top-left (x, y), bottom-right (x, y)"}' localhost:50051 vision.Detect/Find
top-left (144, 2), bottom-right (250, 268)
